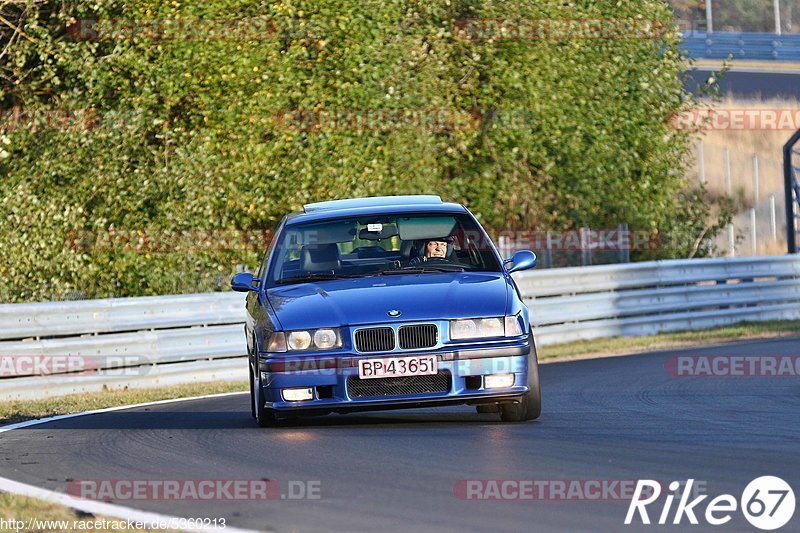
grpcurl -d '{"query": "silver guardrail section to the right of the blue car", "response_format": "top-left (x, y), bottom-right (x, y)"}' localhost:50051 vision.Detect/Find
top-left (516, 256), bottom-right (800, 345)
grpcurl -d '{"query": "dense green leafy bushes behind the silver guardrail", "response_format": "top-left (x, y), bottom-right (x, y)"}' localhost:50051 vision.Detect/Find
top-left (0, 0), bottom-right (712, 301)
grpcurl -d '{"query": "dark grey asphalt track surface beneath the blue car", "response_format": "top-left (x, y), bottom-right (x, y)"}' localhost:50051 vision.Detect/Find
top-left (0, 337), bottom-right (800, 532)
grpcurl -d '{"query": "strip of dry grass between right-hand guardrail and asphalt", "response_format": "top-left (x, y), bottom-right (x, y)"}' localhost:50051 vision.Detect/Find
top-left (539, 320), bottom-right (800, 360)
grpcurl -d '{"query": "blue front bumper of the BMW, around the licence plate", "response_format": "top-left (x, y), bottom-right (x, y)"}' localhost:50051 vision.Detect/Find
top-left (259, 341), bottom-right (531, 414)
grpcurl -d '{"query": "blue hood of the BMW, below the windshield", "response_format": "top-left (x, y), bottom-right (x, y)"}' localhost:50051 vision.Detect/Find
top-left (267, 272), bottom-right (509, 330)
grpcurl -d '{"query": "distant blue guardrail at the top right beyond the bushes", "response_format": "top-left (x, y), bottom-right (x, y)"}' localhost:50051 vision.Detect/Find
top-left (682, 31), bottom-right (800, 61)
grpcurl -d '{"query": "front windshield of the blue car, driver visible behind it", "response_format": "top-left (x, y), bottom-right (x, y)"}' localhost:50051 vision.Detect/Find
top-left (270, 214), bottom-right (501, 284)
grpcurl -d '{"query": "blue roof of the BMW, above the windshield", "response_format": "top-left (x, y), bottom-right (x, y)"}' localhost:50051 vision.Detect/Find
top-left (286, 195), bottom-right (467, 223)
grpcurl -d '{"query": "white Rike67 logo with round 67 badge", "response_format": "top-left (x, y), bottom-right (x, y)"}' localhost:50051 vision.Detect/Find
top-left (625, 476), bottom-right (795, 531)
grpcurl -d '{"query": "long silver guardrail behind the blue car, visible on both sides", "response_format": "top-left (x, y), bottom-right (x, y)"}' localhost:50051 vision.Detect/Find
top-left (0, 256), bottom-right (800, 400)
